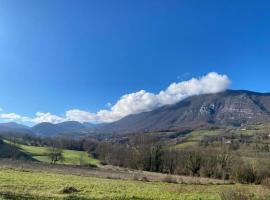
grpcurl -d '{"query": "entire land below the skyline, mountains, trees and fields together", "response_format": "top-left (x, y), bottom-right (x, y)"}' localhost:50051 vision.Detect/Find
top-left (0, 91), bottom-right (270, 200)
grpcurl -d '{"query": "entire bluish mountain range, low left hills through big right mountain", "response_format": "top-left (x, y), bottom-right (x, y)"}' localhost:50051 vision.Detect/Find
top-left (0, 90), bottom-right (270, 136)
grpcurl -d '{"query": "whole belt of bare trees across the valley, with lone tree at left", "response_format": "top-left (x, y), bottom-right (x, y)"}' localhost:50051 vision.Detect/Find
top-left (3, 130), bottom-right (270, 183)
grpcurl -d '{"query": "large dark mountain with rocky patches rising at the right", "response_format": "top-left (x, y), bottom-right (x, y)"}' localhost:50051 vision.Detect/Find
top-left (92, 90), bottom-right (270, 133)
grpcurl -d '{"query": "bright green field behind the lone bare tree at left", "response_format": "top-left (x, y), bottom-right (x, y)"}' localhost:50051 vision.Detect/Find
top-left (5, 141), bottom-right (99, 166)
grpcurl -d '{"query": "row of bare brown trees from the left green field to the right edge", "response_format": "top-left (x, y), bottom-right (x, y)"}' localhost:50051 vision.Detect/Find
top-left (93, 133), bottom-right (270, 184)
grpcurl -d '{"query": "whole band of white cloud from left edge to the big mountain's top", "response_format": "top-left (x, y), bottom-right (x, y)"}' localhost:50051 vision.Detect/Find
top-left (1, 72), bottom-right (230, 123)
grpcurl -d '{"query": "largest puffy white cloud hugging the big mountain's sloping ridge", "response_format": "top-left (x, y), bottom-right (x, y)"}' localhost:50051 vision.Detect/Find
top-left (90, 72), bottom-right (230, 122)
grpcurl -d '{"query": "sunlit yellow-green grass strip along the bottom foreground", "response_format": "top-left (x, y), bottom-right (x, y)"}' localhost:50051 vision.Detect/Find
top-left (0, 169), bottom-right (268, 200)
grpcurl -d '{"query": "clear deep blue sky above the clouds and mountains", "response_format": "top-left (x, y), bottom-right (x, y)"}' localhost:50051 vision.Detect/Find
top-left (0, 0), bottom-right (270, 123)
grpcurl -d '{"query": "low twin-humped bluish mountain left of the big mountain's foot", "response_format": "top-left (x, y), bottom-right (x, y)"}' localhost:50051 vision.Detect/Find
top-left (32, 121), bottom-right (87, 136)
